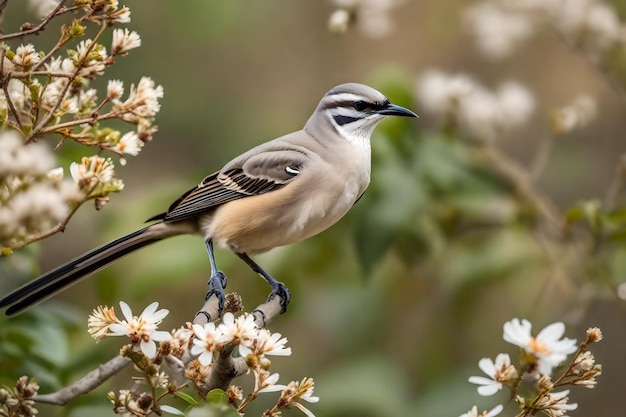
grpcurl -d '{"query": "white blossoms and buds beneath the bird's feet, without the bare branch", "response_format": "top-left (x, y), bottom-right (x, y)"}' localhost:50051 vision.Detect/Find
top-left (88, 301), bottom-right (319, 416)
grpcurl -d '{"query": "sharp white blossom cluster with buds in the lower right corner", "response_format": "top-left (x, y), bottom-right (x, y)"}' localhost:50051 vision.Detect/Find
top-left (461, 319), bottom-right (602, 417)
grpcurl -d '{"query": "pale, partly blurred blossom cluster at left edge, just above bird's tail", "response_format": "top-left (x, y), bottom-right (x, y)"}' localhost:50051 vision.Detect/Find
top-left (0, 130), bottom-right (124, 248)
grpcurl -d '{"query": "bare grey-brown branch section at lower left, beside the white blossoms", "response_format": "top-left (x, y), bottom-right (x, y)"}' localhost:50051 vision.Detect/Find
top-left (32, 355), bottom-right (131, 405)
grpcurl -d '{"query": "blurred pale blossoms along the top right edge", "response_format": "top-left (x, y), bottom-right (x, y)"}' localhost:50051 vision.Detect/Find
top-left (465, 0), bottom-right (626, 59)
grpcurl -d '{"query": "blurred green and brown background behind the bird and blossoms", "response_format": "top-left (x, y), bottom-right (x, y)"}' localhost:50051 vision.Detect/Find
top-left (0, 0), bottom-right (626, 417)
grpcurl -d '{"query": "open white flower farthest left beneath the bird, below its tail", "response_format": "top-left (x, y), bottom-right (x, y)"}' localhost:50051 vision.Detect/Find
top-left (109, 301), bottom-right (172, 359)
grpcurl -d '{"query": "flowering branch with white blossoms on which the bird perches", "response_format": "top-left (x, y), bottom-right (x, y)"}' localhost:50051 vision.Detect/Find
top-left (4, 294), bottom-right (302, 415)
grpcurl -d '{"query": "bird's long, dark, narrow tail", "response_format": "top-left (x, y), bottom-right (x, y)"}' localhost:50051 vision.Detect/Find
top-left (0, 223), bottom-right (193, 316)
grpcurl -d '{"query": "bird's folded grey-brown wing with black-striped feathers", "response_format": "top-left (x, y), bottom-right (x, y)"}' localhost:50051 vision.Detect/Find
top-left (149, 144), bottom-right (309, 221)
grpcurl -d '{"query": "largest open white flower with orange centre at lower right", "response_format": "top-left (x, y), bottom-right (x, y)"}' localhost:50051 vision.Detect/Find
top-left (503, 319), bottom-right (577, 375)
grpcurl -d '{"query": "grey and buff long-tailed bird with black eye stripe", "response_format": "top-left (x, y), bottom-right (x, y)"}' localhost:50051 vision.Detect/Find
top-left (0, 83), bottom-right (418, 316)
